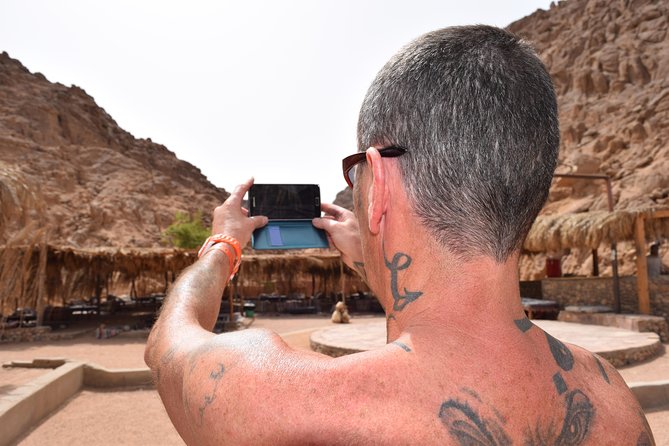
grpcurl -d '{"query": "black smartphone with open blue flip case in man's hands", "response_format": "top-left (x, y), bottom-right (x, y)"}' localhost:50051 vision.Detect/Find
top-left (249, 184), bottom-right (328, 249)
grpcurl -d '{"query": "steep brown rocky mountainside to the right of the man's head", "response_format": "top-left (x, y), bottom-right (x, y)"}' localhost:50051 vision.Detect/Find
top-left (336, 0), bottom-right (669, 279)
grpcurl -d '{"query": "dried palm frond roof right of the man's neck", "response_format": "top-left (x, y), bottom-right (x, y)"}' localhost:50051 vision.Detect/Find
top-left (524, 209), bottom-right (669, 252)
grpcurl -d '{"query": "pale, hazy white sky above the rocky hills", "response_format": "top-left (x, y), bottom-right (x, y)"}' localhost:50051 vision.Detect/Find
top-left (0, 0), bottom-right (551, 201)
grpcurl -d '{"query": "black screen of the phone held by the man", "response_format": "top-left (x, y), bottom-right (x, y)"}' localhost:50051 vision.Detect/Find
top-left (249, 184), bottom-right (321, 220)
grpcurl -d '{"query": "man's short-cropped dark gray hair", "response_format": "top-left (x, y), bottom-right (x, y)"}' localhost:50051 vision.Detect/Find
top-left (358, 25), bottom-right (560, 262)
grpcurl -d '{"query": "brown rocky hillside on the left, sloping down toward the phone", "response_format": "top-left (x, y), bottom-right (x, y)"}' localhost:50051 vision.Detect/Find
top-left (0, 53), bottom-right (227, 247)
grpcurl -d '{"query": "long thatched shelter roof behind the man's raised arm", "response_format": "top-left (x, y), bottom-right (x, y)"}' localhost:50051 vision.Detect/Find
top-left (0, 242), bottom-right (357, 316)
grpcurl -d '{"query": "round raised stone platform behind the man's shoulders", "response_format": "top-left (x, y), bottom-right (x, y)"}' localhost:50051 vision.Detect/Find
top-left (310, 319), bottom-right (662, 367)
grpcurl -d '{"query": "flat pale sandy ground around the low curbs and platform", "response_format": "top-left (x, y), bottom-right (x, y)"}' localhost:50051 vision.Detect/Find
top-left (0, 316), bottom-right (669, 446)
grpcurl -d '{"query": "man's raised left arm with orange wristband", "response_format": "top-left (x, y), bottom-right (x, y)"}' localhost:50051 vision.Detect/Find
top-left (144, 179), bottom-right (267, 443)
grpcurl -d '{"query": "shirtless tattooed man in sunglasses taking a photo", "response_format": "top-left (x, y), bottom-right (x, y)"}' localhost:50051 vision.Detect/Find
top-left (146, 26), bottom-right (653, 446)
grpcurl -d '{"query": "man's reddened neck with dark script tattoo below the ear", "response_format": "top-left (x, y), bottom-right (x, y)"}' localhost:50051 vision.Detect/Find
top-left (378, 235), bottom-right (524, 342)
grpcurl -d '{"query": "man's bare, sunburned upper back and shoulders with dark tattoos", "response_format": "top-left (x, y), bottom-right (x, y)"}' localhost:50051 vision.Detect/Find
top-left (172, 320), bottom-right (651, 445)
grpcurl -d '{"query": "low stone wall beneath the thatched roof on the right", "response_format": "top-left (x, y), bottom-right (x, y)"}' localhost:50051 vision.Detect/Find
top-left (541, 276), bottom-right (669, 322)
